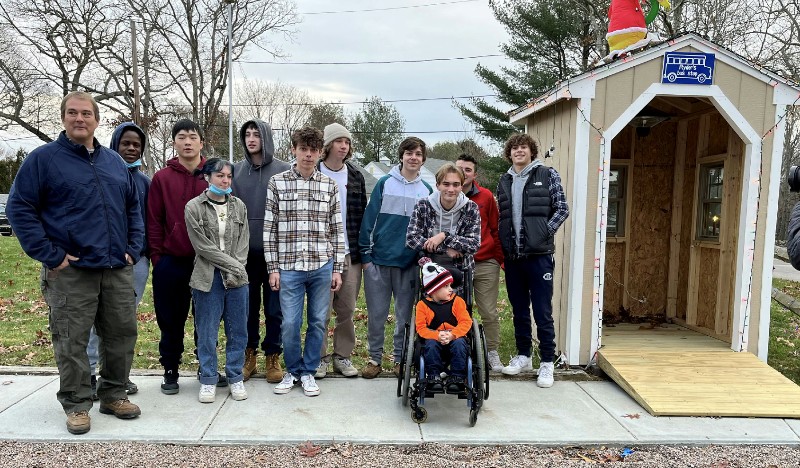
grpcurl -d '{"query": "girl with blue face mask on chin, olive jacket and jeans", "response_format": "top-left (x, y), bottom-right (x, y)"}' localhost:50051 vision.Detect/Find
top-left (185, 158), bottom-right (250, 403)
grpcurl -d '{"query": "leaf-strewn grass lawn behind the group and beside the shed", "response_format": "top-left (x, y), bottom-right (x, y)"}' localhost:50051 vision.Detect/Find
top-left (0, 233), bottom-right (800, 383)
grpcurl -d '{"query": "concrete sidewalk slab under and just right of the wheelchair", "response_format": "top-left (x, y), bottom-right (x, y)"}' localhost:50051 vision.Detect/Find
top-left (418, 381), bottom-right (633, 444)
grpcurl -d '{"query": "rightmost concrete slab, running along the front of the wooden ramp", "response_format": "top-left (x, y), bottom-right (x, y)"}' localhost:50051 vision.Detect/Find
top-left (578, 382), bottom-right (800, 444)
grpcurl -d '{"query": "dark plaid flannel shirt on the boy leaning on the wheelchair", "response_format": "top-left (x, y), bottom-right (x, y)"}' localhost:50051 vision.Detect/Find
top-left (406, 198), bottom-right (481, 271)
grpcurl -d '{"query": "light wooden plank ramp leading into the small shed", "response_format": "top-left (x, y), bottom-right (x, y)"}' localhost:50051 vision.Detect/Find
top-left (597, 324), bottom-right (800, 418)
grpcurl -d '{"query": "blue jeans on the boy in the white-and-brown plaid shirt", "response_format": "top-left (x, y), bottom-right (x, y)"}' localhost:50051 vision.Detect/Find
top-left (280, 261), bottom-right (333, 377)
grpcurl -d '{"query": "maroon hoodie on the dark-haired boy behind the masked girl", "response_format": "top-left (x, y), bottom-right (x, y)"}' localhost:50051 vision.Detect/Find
top-left (147, 157), bottom-right (208, 265)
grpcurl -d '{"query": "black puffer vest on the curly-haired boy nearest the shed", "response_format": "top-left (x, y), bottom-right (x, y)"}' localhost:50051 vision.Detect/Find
top-left (497, 166), bottom-right (556, 259)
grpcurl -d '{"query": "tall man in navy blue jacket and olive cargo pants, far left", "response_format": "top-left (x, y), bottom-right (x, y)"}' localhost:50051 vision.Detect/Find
top-left (6, 91), bottom-right (144, 434)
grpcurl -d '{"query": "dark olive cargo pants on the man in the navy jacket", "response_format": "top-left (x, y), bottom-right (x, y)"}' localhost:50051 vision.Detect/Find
top-left (40, 266), bottom-right (136, 413)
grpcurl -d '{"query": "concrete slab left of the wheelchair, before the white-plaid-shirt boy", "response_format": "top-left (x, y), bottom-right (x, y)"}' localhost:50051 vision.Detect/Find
top-left (203, 378), bottom-right (422, 444)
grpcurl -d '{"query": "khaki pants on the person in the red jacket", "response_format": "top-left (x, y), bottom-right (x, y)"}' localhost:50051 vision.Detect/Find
top-left (472, 259), bottom-right (500, 351)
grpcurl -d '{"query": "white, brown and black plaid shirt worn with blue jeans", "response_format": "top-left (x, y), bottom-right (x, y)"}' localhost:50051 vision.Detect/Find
top-left (264, 164), bottom-right (344, 273)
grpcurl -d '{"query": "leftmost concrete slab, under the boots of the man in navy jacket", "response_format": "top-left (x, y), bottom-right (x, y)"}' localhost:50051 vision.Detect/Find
top-left (0, 377), bottom-right (227, 443)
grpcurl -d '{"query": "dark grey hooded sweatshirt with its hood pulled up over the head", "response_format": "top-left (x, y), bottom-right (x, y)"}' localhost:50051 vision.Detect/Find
top-left (231, 120), bottom-right (291, 252)
